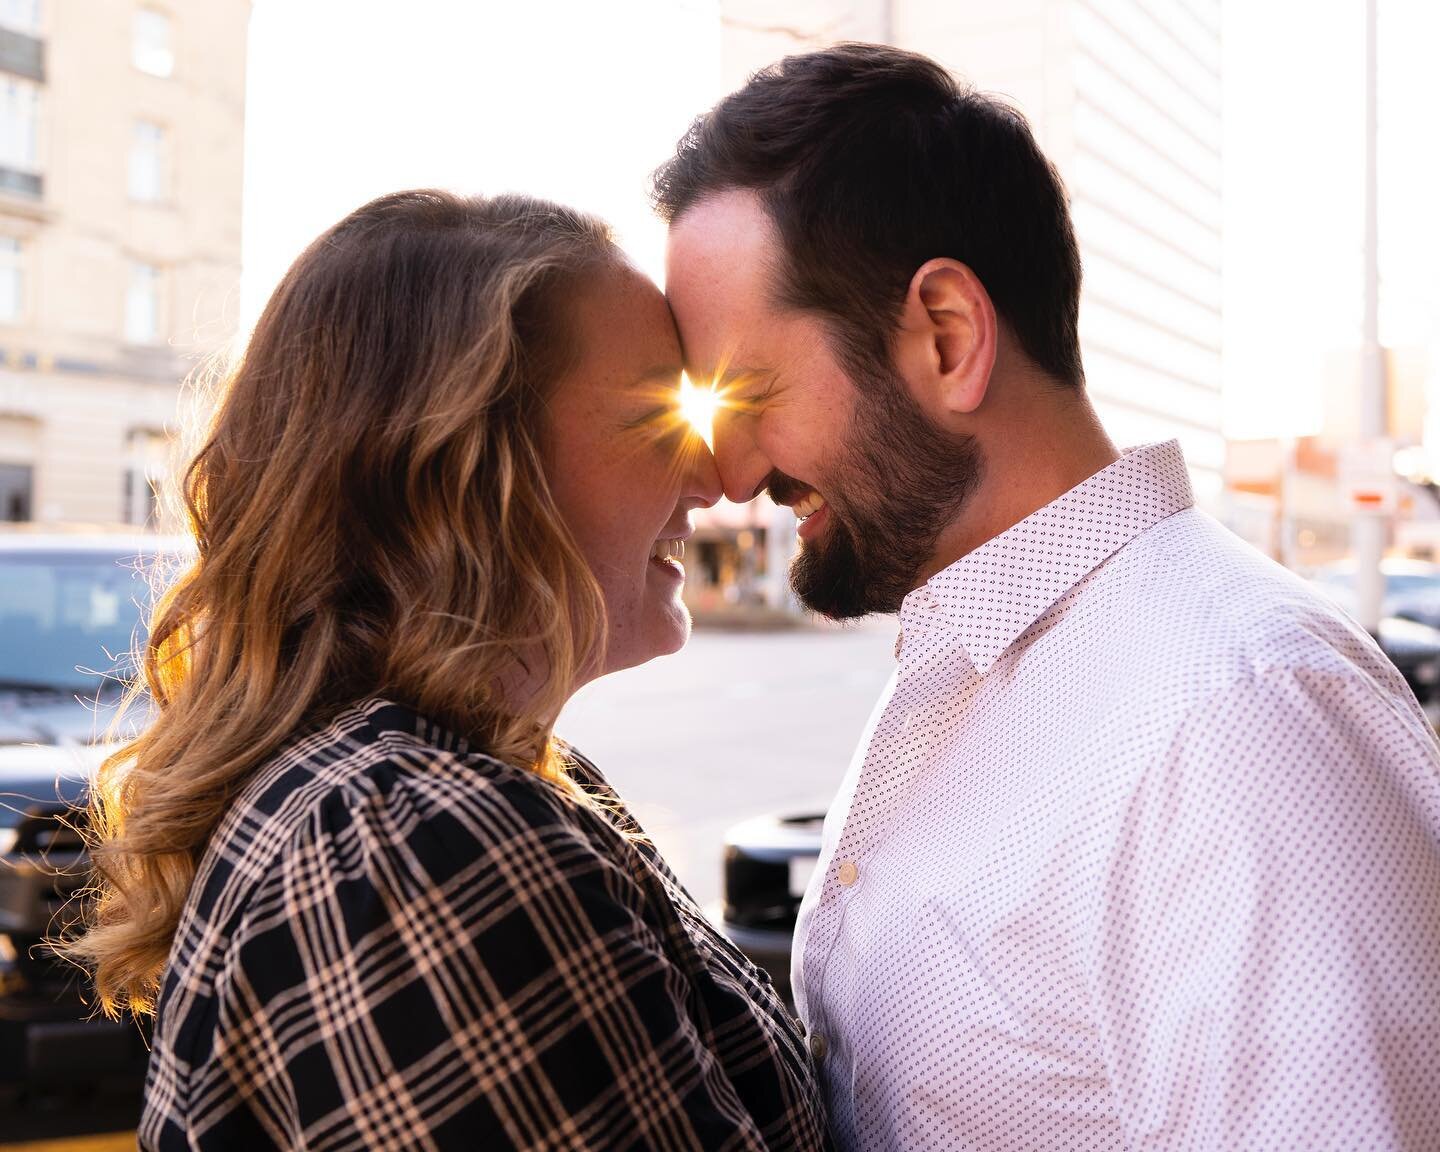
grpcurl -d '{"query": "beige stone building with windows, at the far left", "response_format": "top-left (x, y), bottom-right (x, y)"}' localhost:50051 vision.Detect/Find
top-left (0, 0), bottom-right (251, 524)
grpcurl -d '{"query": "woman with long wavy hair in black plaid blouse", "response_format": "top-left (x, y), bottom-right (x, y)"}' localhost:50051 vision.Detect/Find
top-left (75, 192), bottom-right (825, 1149)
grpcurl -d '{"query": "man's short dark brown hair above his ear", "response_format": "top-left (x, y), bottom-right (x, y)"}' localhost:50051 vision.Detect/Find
top-left (652, 43), bottom-right (1084, 387)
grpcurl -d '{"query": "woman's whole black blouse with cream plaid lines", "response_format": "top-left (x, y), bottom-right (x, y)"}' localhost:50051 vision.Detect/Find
top-left (138, 700), bottom-right (831, 1152)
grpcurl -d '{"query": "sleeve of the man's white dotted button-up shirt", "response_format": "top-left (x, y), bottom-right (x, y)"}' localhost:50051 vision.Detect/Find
top-left (1093, 670), bottom-right (1440, 1152)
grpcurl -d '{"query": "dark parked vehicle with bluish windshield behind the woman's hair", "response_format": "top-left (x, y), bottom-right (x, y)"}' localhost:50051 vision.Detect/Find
top-left (0, 528), bottom-right (183, 1138)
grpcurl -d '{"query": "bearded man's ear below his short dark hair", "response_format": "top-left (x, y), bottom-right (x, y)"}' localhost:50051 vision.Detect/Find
top-left (894, 259), bottom-right (999, 420)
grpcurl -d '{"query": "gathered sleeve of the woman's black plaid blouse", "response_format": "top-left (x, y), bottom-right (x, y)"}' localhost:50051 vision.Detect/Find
top-left (201, 779), bottom-right (763, 1151)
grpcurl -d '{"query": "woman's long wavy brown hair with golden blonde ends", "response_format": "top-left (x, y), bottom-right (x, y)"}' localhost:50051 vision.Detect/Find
top-left (62, 190), bottom-right (619, 1014)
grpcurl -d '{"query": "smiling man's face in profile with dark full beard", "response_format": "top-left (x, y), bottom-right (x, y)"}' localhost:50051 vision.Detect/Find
top-left (667, 192), bottom-right (979, 619)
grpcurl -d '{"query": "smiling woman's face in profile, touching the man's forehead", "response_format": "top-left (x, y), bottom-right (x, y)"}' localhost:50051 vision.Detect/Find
top-left (546, 266), bottom-right (720, 672)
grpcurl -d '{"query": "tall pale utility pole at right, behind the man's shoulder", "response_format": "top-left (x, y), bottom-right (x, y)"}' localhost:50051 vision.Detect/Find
top-left (1351, 0), bottom-right (1394, 636)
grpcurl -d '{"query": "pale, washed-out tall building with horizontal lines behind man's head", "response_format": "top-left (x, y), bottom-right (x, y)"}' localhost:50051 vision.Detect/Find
top-left (721, 0), bottom-right (1225, 507)
